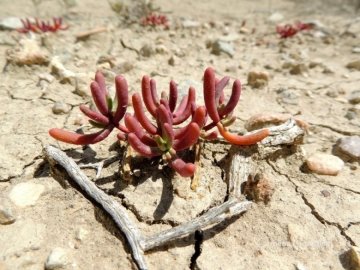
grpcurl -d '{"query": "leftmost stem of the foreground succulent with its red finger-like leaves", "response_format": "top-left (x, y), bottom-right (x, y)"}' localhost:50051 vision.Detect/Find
top-left (49, 72), bottom-right (128, 145)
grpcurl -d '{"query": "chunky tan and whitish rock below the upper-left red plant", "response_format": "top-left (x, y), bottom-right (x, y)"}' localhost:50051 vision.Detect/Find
top-left (6, 38), bottom-right (49, 66)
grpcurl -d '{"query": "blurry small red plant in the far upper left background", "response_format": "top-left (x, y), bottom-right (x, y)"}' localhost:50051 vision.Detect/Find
top-left (17, 18), bottom-right (69, 33)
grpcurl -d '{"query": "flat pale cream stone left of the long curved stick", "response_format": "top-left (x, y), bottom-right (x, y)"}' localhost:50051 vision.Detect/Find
top-left (9, 182), bottom-right (45, 207)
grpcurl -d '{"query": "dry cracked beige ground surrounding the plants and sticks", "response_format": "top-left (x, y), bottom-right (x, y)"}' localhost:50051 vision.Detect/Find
top-left (0, 0), bottom-right (360, 270)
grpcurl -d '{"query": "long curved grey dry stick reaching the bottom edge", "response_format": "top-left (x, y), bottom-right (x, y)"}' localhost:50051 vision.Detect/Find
top-left (44, 146), bottom-right (147, 269)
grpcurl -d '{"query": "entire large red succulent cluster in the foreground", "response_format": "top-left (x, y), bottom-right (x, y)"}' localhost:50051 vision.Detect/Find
top-left (49, 68), bottom-right (269, 177)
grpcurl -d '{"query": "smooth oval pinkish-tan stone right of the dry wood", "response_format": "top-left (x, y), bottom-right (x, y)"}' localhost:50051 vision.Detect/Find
top-left (306, 153), bottom-right (344, 175)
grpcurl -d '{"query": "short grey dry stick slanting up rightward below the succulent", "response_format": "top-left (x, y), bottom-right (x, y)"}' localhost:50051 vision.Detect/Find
top-left (140, 198), bottom-right (251, 251)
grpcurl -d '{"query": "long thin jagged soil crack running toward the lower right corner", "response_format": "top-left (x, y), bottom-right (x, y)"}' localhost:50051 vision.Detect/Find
top-left (266, 159), bottom-right (355, 246)
